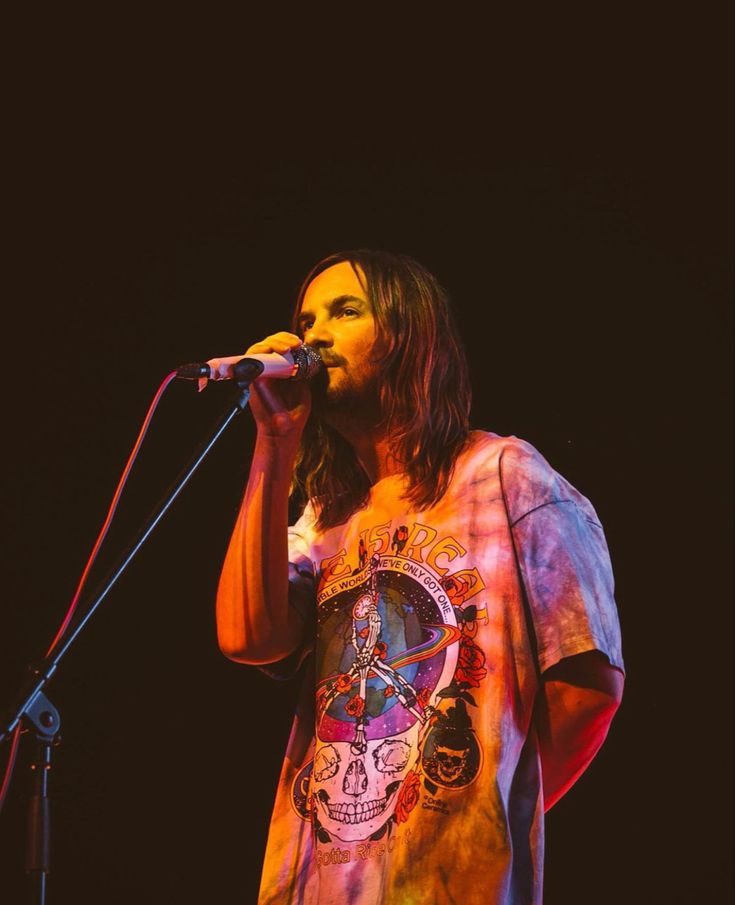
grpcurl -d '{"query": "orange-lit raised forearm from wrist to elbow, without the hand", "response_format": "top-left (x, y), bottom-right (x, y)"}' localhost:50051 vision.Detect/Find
top-left (217, 436), bottom-right (300, 663)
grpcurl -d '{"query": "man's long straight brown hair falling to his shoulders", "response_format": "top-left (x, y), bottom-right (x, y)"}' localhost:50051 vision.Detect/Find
top-left (291, 249), bottom-right (471, 531)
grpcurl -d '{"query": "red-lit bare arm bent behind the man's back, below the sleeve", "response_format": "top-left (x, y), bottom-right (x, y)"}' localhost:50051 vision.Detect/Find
top-left (535, 651), bottom-right (623, 811)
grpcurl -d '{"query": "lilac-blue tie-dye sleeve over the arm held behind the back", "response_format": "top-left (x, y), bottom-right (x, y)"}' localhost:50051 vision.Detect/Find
top-left (500, 439), bottom-right (624, 672)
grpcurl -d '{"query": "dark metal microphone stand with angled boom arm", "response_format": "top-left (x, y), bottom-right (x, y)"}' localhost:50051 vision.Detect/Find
top-left (0, 370), bottom-right (262, 905)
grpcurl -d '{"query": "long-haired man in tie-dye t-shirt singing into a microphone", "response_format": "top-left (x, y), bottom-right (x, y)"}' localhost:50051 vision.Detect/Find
top-left (217, 250), bottom-right (623, 905)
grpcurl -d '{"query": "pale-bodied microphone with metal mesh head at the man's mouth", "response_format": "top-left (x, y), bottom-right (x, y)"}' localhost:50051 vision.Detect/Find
top-left (176, 344), bottom-right (323, 388)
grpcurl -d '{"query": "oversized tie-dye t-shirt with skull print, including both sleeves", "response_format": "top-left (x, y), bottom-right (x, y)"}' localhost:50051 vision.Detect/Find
top-left (259, 431), bottom-right (623, 905)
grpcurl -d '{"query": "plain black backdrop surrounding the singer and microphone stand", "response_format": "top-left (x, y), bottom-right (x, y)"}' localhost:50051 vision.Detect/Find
top-left (0, 4), bottom-right (733, 905)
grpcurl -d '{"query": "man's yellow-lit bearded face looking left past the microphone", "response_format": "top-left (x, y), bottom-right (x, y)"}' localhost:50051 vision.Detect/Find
top-left (299, 261), bottom-right (380, 416)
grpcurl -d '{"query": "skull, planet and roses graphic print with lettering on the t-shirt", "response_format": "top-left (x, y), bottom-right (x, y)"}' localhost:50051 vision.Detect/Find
top-left (293, 523), bottom-right (487, 863)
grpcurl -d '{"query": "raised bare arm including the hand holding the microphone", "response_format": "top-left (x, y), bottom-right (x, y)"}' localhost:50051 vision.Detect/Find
top-left (217, 333), bottom-right (310, 665)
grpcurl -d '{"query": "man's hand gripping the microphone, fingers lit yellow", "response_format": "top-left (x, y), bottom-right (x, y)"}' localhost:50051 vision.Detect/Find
top-left (245, 332), bottom-right (311, 442)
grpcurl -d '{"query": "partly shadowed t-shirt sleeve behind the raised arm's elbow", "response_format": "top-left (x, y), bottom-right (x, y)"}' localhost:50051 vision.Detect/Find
top-left (258, 504), bottom-right (316, 681)
